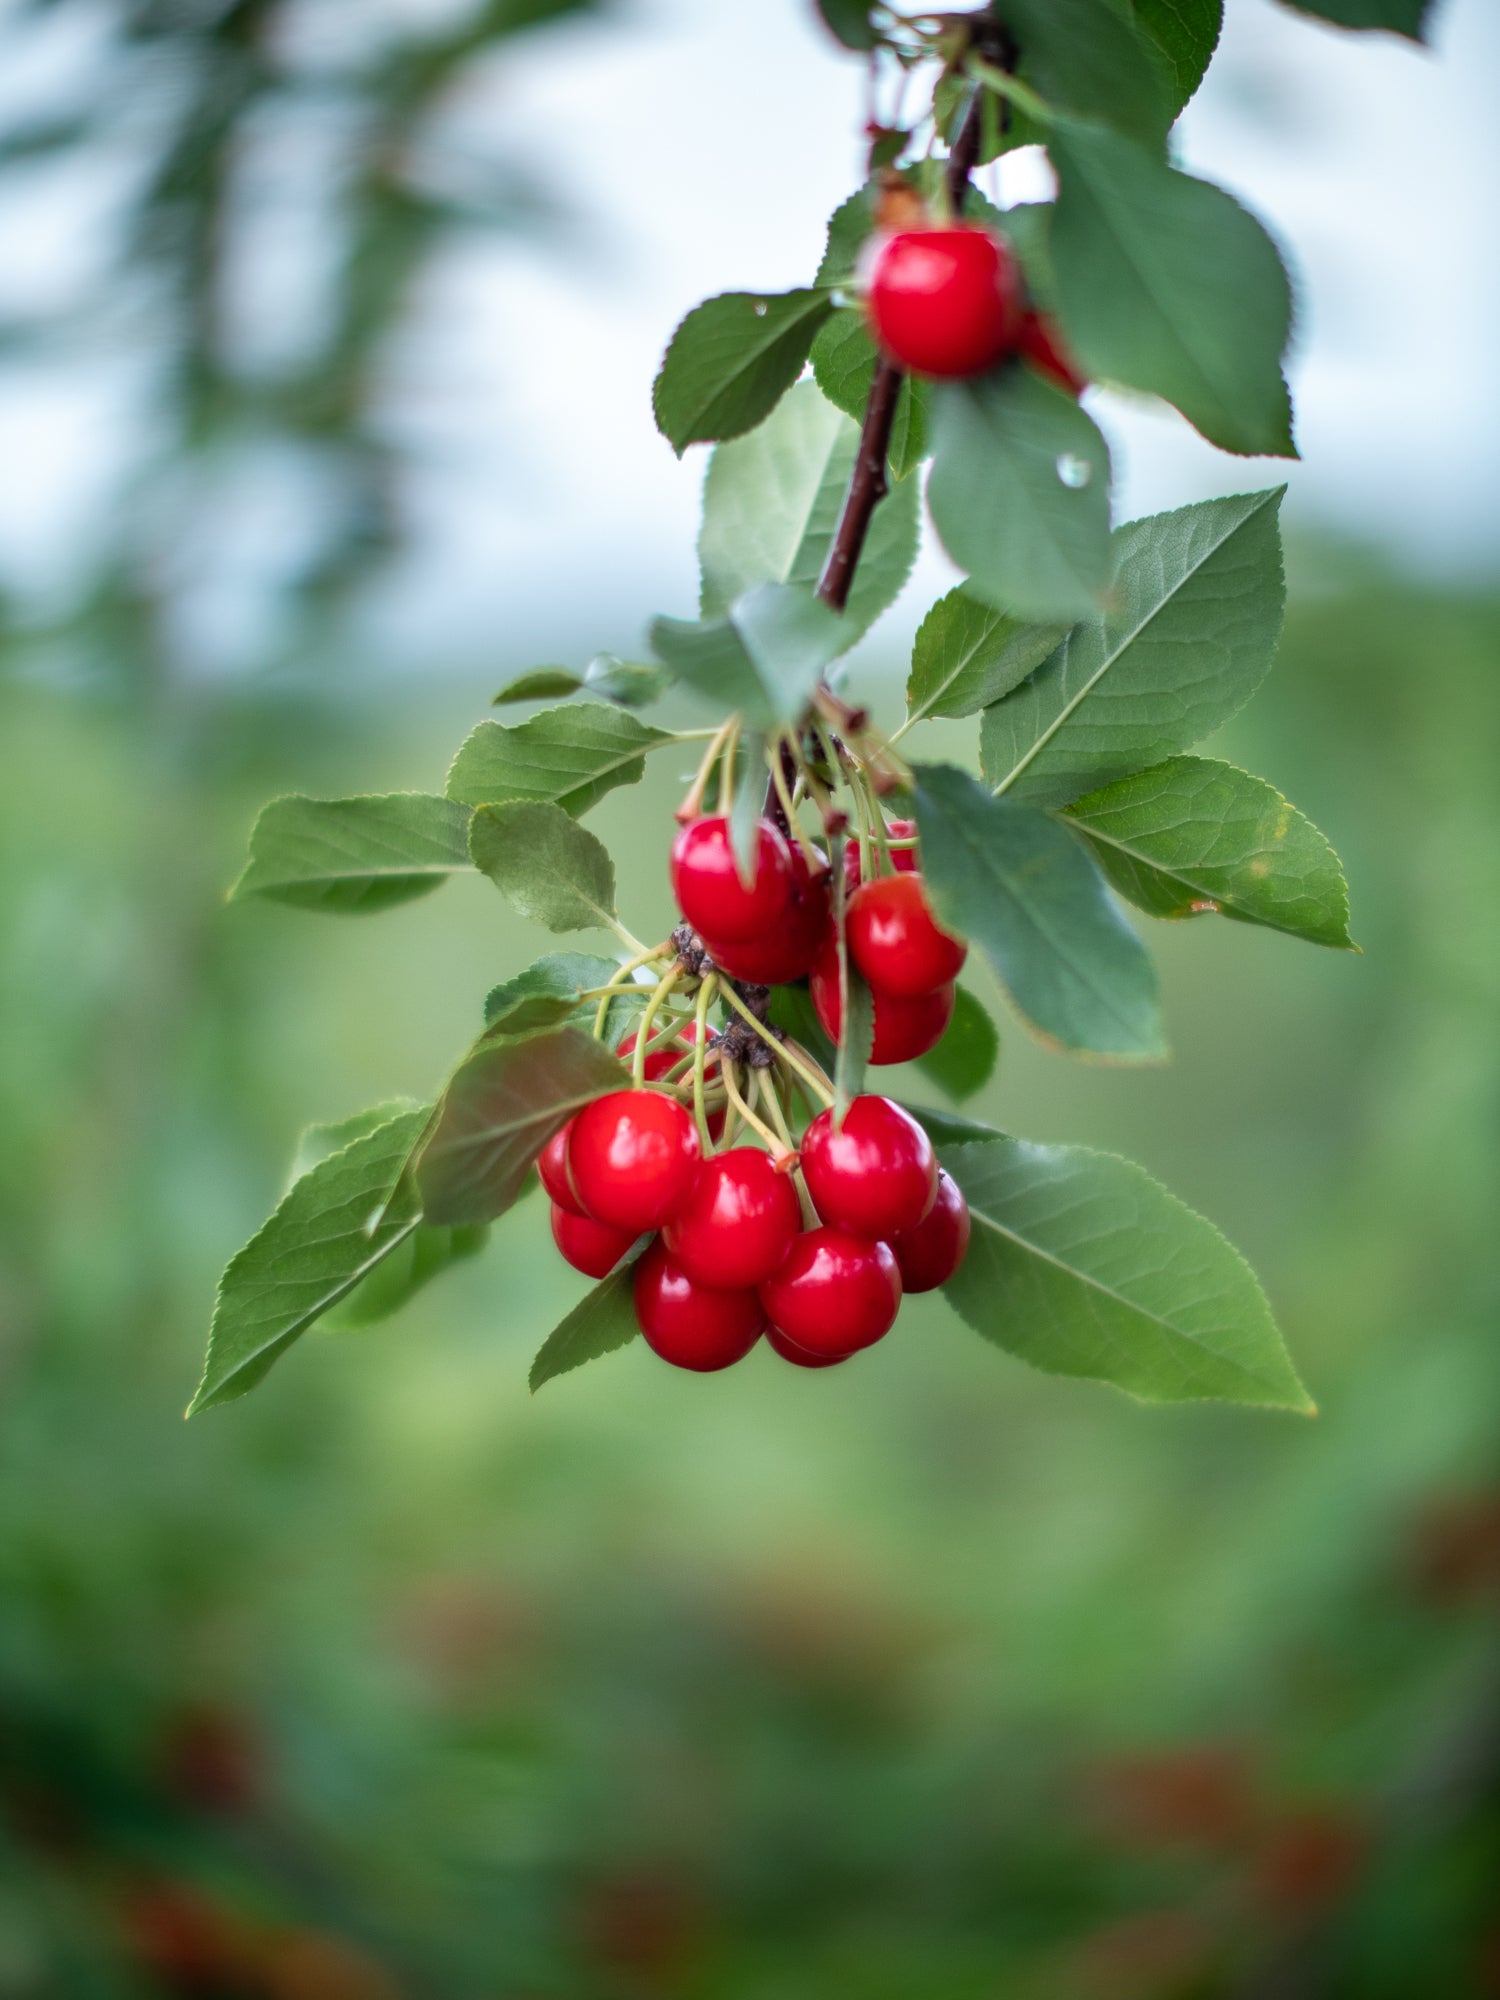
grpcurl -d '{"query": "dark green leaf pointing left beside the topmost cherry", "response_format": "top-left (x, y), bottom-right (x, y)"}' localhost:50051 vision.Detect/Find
top-left (652, 290), bottom-right (834, 458)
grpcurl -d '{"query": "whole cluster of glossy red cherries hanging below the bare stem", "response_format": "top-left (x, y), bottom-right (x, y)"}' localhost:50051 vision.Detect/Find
top-left (538, 814), bottom-right (970, 1372)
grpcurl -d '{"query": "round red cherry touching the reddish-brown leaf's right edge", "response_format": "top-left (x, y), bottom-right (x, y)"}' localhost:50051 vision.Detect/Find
top-left (568, 1090), bottom-right (698, 1236)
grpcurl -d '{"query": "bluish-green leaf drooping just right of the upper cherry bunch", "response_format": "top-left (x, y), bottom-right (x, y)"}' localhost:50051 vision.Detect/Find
top-left (912, 764), bottom-right (1166, 1062)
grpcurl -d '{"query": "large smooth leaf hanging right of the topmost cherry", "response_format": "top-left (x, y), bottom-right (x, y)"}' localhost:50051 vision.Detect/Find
top-left (1050, 124), bottom-right (1296, 458)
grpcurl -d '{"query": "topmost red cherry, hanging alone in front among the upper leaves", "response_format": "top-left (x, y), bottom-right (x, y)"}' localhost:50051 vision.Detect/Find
top-left (866, 224), bottom-right (1024, 378)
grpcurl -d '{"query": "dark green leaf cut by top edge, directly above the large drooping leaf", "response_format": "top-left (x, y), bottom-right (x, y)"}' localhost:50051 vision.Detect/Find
top-left (994, 0), bottom-right (1172, 146)
